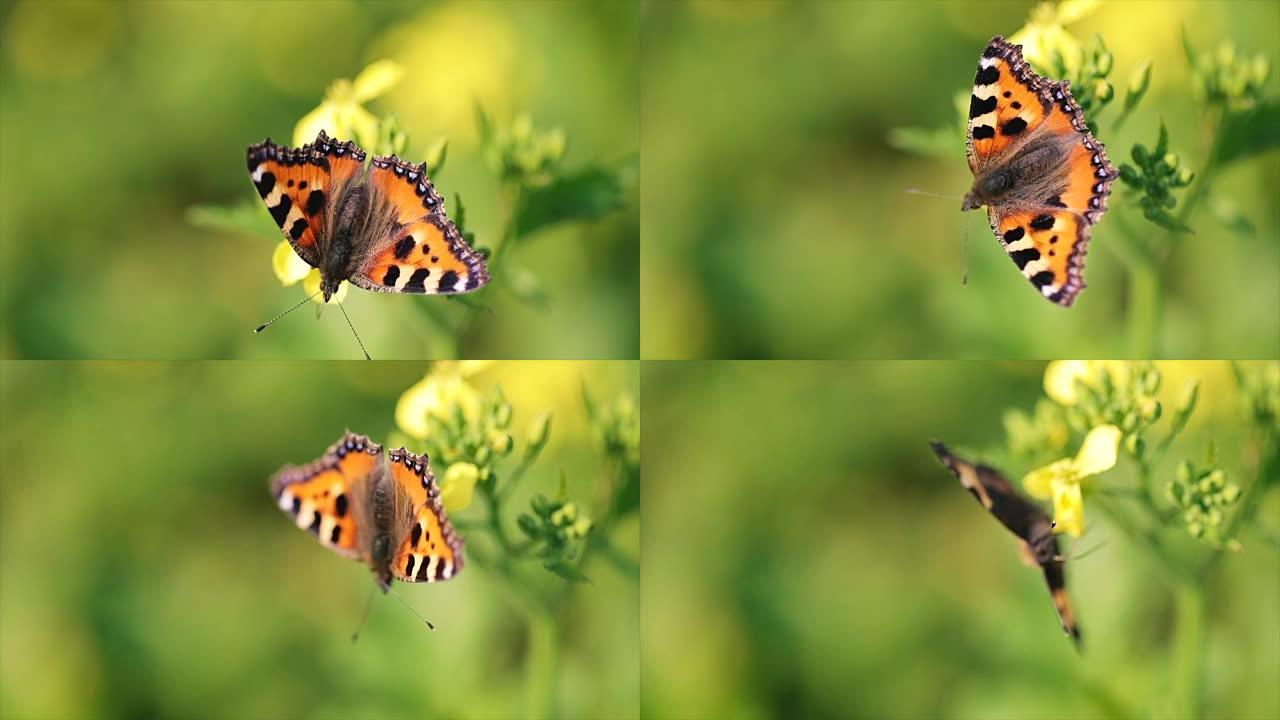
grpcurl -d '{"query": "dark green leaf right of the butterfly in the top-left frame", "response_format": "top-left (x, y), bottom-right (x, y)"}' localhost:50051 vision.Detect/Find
top-left (516, 165), bottom-right (626, 236)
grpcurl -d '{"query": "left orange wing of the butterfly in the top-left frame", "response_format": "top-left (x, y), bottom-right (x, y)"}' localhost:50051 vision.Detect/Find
top-left (248, 131), bottom-right (365, 268)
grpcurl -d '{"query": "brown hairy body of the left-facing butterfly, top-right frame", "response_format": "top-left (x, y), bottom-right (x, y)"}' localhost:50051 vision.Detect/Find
top-left (960, 132), bottom-right (1071, 211)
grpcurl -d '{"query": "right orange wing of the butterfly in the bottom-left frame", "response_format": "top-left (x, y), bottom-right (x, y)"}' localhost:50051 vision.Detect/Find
top-left (388, 448), bottom-right (462, 583)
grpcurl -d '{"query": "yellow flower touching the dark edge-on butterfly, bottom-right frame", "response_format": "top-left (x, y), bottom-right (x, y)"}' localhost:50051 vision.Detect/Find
top-left (1023, 425), bottom-right (1121, 537)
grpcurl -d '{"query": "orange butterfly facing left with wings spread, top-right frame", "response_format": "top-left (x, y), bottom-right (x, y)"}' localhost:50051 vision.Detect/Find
top-left (961, 36), bottom-right (1120, 307)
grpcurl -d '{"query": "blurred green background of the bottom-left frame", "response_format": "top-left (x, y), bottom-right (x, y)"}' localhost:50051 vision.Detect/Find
top-left (0, 361), bottom-right (640, 717)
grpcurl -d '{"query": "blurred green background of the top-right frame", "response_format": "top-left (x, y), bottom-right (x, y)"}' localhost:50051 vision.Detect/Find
top-left (641, 1), bottom-right (1280, 359)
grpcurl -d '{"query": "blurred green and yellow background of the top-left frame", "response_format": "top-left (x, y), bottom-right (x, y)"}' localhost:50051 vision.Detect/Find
top-left (0, 1), bottom-right (640, 359)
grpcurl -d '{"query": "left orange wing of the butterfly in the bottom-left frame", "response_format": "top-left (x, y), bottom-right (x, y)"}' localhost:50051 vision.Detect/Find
top-left (271, 432), bottom-right (383, 560)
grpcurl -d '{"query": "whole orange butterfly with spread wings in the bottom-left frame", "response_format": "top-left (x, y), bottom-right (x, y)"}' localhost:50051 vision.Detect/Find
top-left (270, 430), bottom-right (462, 592)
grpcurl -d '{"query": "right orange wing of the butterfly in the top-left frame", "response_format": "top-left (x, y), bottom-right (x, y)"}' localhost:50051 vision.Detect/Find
top-left (351, 156), bottom-right (489, 295)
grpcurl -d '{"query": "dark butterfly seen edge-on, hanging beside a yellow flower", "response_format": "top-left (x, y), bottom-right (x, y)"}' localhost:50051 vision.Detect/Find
top-left (929, 442), bottom-right (1082, 647)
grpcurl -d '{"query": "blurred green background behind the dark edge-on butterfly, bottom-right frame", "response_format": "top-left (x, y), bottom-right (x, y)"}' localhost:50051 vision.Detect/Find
top-left (641, 361), bottom-right (1280, 719)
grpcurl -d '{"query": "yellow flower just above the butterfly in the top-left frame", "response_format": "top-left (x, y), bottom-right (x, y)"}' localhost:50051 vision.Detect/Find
top-left (293, 60), bottom-right (404, 149)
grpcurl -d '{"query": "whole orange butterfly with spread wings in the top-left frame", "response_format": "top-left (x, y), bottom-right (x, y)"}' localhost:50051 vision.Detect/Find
top-left (248, 131), bottom-right (489, 302)
